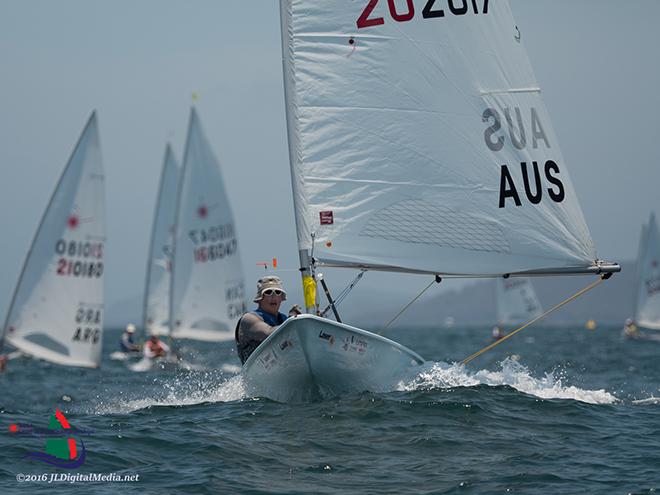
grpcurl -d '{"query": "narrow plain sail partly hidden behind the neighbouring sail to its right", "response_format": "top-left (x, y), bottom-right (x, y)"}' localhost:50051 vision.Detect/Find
top-left (143, 144), bottom-right (179, 335)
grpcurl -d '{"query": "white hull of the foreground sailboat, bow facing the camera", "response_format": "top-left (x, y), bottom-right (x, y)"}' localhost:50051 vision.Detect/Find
top-left (242, 315), bottom-right (424, 402)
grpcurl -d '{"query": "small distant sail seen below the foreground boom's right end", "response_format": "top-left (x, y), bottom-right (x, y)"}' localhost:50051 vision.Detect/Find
top-left (495, 277), bottom-right (543, 325)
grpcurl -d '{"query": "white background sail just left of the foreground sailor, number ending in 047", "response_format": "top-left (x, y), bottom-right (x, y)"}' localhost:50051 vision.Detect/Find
top-left (170, 108), bottom-right (247, 341)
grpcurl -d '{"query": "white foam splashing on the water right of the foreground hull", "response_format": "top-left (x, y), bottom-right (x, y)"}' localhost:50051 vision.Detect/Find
top-left (401, 358), bottom-right (618, 404)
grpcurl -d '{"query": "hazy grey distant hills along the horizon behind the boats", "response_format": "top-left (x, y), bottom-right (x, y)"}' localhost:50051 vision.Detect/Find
top-left (105, 262), bottom-right (635, 328)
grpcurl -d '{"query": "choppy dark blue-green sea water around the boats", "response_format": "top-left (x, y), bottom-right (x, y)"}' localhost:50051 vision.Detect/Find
top-left (0, 325), bottom-right (660, 495)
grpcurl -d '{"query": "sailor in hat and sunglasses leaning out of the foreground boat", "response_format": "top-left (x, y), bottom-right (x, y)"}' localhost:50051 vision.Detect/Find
top-left (235, 275), bottom-right (302, 364)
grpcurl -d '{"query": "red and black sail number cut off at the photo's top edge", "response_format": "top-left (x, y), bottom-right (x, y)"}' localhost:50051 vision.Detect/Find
top-left (357, 0), bottom-right (488, 29)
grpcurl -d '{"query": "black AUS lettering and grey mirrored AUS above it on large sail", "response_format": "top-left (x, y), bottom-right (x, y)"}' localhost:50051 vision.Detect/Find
top-left (482, 107), bottom-right (566, 208)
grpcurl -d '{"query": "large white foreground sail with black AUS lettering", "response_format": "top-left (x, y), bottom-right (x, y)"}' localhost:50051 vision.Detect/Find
top-left (281, 0), bottom-right (618, 276)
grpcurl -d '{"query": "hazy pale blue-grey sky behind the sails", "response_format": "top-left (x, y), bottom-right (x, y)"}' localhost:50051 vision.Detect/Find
top-left (0, 0), bottom-right (660, 330)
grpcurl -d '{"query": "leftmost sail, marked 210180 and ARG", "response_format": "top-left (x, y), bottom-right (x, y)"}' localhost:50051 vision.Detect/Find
top-left (4, 113), bottom-right (105, 367)
